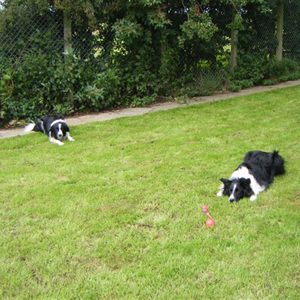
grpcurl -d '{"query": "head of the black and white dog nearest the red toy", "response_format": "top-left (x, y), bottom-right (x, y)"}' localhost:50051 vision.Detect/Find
top-left (220, 178), bottom-right (253, 202)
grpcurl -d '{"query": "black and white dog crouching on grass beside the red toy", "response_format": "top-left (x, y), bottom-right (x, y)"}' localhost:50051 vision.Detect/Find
top-left (217, 151), bottom-right (285, 202)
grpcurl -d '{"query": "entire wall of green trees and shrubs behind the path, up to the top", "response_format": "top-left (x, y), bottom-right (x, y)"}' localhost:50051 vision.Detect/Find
top-left (0, 0), bottom-right (300, 123)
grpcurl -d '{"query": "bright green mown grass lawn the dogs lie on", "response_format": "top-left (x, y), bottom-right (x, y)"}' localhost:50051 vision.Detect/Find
top-left (0, 87), bottom-right (300, 299)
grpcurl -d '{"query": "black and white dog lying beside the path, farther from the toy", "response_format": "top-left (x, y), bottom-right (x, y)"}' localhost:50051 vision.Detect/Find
top-left (25, 116), bottom-right (74, 146)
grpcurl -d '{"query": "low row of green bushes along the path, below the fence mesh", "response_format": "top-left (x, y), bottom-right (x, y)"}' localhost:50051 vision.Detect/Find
top-left (0, 44), bottom-right (300, 124)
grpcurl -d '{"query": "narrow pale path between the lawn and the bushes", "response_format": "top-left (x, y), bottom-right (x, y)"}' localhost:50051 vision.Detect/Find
top-left (0, 80), bottom-right (300, 138)
